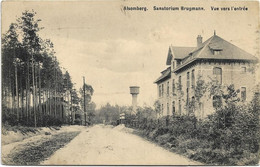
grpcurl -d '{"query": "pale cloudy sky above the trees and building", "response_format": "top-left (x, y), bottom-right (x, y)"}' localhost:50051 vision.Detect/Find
top-left (2, 0), bottom-right (259, 107)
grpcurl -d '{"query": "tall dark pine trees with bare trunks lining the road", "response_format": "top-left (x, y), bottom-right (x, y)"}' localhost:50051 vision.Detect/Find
top-left (2, 10), bottom-right (94, 127)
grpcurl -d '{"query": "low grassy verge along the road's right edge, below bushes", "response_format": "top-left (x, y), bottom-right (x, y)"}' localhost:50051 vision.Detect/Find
top-left (133, 129), bottom-right (259, 166)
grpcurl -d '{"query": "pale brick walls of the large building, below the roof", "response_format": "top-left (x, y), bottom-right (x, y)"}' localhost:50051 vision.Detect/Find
top-left (157, 60), bottom-right (256, 118)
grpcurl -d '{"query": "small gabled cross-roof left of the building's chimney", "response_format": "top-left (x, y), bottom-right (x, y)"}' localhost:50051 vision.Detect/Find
top-left (166, 45), bottom-right (195, 65)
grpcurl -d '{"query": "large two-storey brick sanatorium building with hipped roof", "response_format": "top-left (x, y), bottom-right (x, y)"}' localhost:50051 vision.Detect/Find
top-left (155, 32), bottom-right (258, 118)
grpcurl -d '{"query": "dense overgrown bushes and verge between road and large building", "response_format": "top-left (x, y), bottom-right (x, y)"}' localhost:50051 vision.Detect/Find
top-left (127, 92), bottom-right (260, 165)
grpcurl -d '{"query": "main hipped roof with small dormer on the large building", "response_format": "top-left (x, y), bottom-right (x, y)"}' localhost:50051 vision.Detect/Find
top-left (174, 35), bottom-right (258, 71)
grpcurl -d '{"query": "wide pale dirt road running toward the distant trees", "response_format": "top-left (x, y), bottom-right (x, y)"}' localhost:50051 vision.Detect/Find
top-left (41, 125), bottom-right (200, 165)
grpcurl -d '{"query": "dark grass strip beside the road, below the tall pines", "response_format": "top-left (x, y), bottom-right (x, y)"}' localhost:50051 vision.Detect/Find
top-left (3, 131), bottom-right (80, 165)
